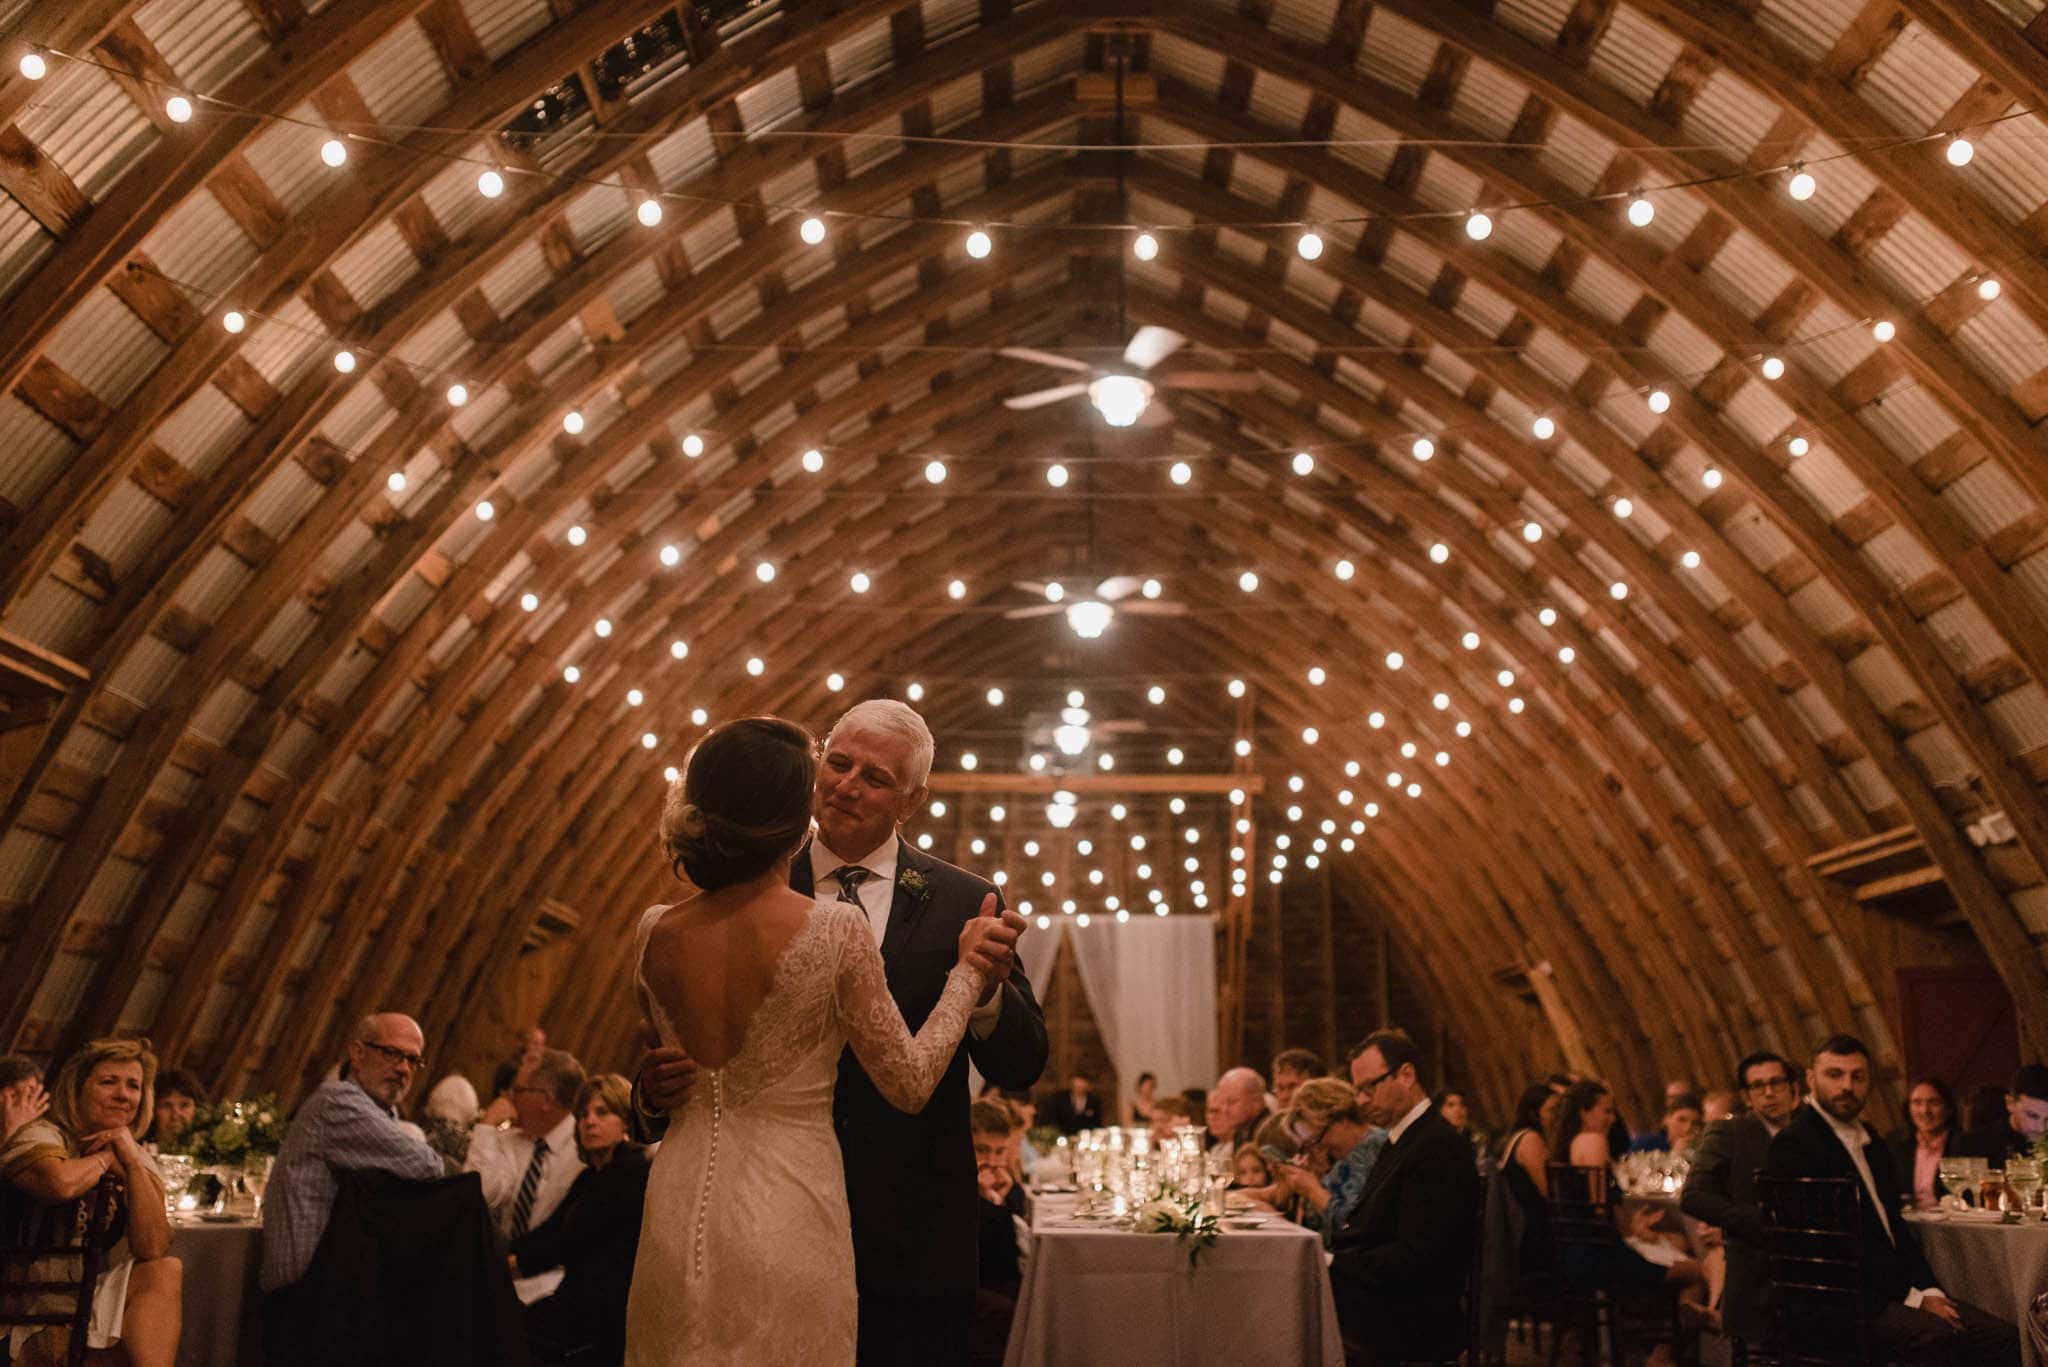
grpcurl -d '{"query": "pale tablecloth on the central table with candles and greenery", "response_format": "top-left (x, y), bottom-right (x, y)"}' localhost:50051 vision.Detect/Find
top-left (1004, 1197), bottom-right (1343, 1367)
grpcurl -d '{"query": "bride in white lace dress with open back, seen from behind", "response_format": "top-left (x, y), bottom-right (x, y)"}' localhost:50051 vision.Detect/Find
top-left (627, 717), bottom-right (997, 1367)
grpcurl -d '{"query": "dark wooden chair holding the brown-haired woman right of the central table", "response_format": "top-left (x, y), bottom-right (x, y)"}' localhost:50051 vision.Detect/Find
top-left (1544, 1162), bottom-right (1698, 1367)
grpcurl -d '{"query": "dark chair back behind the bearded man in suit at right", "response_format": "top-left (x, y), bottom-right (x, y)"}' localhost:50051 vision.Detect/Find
top-left (1757, 1176), bottom-right (1876, 1363)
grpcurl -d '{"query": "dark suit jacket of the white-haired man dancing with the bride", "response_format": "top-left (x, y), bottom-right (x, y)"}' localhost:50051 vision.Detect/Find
top-left (788, 840), bottom-right (1047, 1297)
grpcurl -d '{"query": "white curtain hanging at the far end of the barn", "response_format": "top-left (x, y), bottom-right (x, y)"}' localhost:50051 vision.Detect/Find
top-left (1051, 914), bottom-right (1217, 1096)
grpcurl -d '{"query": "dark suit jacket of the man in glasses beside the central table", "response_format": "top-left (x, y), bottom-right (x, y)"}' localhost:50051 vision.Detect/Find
top-left (1329, 1107), bottom-right (1479, 1363)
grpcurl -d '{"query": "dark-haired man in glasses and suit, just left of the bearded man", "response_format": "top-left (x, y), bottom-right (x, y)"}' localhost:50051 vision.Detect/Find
top-left (1677, 1051), bottom-right (1800, 1342)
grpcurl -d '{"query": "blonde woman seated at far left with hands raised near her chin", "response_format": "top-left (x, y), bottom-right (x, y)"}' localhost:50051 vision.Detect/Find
top-left (0, 1039), bottom-right (184, 1367)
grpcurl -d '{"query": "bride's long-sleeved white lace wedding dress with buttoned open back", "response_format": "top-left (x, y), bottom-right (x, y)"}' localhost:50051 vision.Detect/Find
top-left (627, 900), bottom-right (981, 1367)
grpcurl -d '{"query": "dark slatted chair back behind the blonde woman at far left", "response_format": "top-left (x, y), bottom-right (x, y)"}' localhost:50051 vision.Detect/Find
top-left (0, 1178), bottom-right (119, 1367)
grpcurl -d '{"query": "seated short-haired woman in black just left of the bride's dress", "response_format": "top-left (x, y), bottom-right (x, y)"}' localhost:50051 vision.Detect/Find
top-left (507, 1072), bottom-right (647, 1367)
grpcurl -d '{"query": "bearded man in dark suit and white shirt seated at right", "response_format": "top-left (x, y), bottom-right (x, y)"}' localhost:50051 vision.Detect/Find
top-left (1763, 1035), bottom-right (2019, 1367)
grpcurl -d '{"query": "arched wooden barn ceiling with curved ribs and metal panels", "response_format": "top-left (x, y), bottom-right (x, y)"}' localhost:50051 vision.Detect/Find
top-left (0, 0), bottom-right (2048, 1094)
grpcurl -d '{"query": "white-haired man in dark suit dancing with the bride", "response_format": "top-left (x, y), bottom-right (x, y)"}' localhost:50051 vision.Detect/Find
top-left (637, 699), bottom-right (1047, 1367)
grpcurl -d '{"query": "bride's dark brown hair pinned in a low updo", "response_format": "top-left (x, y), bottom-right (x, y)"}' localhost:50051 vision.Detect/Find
top-left (662, 717), bottom-right (817, 892)
